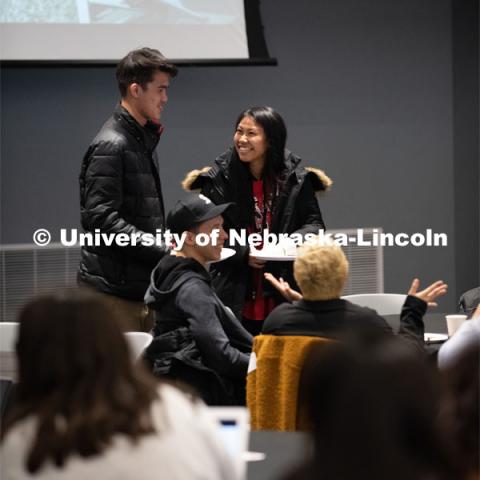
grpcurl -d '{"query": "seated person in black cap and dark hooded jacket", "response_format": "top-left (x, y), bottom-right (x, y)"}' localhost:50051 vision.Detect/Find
top-left (145, 194), bottom-right (252, 405)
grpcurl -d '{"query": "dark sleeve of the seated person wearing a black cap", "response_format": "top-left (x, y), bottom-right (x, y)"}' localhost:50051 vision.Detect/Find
top-left (175, 280), bottom-right (250, 378)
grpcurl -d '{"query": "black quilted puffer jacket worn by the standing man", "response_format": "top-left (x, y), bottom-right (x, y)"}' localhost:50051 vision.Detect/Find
top-left (78, 106), bottom-right (166, 301)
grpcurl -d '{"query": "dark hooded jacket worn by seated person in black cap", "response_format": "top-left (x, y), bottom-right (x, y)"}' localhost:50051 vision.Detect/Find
top-left (145, 255), bottom-right (252, 404)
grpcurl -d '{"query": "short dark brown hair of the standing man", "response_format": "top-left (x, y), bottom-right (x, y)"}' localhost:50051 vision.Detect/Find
top-left (116, 47), bottom-right (177, 98)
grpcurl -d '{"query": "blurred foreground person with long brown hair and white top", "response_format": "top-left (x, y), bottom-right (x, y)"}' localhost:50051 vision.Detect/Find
top-left (1, 292), bottom-right (235, 480)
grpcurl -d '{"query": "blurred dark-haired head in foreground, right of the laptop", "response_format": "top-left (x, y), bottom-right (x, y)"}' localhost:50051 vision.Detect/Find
top-left (283, 340), bottom-right (462, 480)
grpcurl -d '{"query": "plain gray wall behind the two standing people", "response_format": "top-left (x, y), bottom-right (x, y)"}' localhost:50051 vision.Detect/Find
top-left (0, 0), bottom-right (480, 311)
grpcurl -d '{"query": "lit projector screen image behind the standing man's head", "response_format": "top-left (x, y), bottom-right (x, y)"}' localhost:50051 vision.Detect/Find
top-left (0, 0), bottom-right (253, 61)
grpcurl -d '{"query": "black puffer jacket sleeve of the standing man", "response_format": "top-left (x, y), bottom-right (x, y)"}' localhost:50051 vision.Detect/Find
top-left (80, 144), bottom-right (168, 264)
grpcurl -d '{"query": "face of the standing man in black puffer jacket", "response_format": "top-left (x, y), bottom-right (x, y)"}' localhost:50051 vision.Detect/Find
top-left (134, 71), bottom-right (170, 123)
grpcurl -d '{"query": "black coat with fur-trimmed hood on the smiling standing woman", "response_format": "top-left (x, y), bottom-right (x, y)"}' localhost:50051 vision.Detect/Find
top-left (182, 148), bottom-right (332, 318)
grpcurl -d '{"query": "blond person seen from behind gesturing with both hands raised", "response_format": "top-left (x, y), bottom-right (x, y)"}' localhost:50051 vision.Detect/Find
top-left (262, 243), bottom-right (447, 346)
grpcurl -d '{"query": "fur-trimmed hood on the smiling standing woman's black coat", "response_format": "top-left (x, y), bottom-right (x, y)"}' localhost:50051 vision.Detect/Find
top-left (181, 149), bottom-right (333, 193)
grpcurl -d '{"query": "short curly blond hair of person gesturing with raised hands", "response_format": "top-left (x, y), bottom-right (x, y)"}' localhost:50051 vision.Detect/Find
top-left (293, 244), bottom-right (348, 300)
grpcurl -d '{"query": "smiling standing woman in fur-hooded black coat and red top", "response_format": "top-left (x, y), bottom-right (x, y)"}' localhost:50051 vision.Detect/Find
top-left (182, 107), bottom-right (332, 335)
